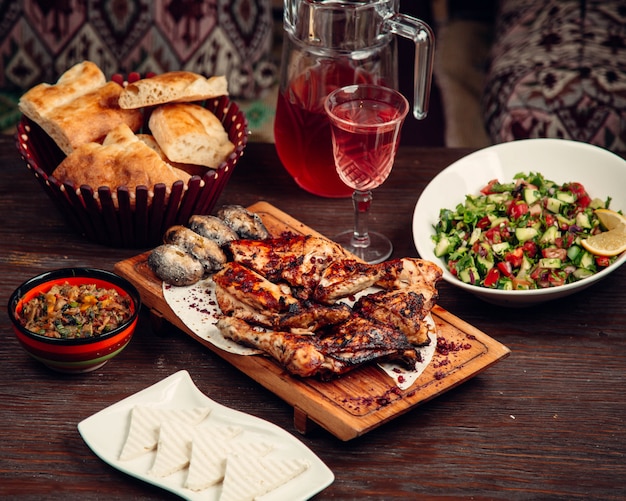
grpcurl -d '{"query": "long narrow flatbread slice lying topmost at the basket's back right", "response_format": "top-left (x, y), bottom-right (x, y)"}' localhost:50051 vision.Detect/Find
top-left (119, 71), bottom-right (228, 109)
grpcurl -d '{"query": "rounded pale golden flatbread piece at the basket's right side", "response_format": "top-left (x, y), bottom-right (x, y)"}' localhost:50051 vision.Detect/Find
top-left (149, 103), bottom-right (235, 168)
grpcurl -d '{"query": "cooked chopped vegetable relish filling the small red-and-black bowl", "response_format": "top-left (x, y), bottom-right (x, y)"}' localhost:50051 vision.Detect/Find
top-left (20, 282), bottom-right (132, 339)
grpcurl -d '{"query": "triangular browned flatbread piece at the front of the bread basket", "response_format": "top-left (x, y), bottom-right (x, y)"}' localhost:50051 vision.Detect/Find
top-left (52, 124), bottom-right (190, 192)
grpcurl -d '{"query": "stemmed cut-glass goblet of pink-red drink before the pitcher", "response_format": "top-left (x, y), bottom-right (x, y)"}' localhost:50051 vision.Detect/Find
top-left (324, 84), bottom-right (409, 264)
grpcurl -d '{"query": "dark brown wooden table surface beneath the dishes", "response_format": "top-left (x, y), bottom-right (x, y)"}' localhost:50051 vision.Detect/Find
top-left (0, 137), bottom-right (626, 500)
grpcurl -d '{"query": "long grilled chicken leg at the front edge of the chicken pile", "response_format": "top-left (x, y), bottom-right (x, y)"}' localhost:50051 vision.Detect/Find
top-left (217, 317), bottom-right (419, 379)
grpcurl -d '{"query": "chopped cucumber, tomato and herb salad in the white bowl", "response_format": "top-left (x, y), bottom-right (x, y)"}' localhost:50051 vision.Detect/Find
top-left (433, 172), bottom-right (616, 290)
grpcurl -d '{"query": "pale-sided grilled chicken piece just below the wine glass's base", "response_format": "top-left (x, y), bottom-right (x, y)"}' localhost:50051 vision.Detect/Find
top-left (313, 259), bottom-right (384, 304)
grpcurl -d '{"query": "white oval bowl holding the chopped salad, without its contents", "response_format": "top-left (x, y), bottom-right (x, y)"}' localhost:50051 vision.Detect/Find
top-left (413, 139), bottom-right (626, 307)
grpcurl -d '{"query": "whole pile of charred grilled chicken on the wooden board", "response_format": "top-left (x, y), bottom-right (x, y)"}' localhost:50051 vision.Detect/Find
top-left (214, 235), bottom-right (442, 378)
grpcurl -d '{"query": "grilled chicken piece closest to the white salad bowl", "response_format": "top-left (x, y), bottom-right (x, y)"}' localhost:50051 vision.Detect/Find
top-left (376, 257), bottom-right (443, 289)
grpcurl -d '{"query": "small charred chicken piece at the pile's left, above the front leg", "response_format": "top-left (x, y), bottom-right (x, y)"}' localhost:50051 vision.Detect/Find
top-left (213, 261), bottom-right (298, 314)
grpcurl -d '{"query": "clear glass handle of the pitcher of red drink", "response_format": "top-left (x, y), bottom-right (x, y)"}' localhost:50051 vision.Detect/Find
top-left (385, 13), bottom-right (435, 120)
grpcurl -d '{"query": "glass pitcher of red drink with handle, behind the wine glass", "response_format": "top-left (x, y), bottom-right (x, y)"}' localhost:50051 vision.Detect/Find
top-left (274, 0), bottom-right (435, 197)
